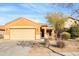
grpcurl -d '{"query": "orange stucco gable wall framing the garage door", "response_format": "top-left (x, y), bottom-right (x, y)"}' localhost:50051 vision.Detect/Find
top-left (4, 18), bottom-right (41, 39)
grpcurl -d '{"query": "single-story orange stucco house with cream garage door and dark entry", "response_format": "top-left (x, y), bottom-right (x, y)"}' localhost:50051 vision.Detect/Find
top-left (4, 17), bottom-right (52, 40)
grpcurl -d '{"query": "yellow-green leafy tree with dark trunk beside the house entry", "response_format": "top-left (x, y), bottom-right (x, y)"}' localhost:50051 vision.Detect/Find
top-left (46, 13), bottom-right (66, 38)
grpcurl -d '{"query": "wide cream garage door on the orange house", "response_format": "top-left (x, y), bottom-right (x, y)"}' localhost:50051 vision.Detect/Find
top-left (10, 28), bottom-right (35, 40)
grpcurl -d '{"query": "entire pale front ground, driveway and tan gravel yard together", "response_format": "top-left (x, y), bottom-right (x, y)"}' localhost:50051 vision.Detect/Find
top-left (0, 40), bottom-right (79, 56)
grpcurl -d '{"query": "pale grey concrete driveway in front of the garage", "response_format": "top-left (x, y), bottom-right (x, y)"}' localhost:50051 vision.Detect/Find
top-left (0, 40), bottom-right (31, 56)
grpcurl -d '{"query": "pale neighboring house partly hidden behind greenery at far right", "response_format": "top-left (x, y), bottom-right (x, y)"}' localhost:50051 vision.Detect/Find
top-left (64, 17), bottom-right (79, 28)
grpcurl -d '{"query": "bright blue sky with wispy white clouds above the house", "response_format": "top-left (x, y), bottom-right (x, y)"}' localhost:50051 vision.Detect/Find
top-left (0, 3), bottom-right (79, 25)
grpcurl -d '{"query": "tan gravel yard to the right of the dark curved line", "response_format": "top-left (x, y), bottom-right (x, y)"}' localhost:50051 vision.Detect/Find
top-left (50, 40), bottom-right (79, 56)
